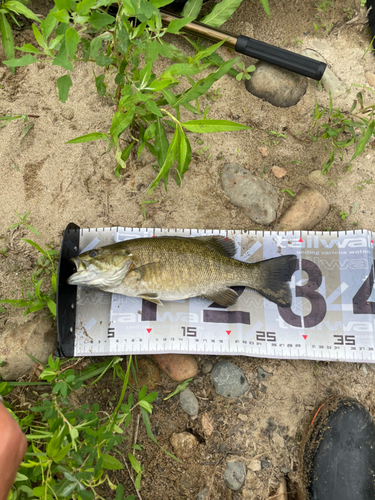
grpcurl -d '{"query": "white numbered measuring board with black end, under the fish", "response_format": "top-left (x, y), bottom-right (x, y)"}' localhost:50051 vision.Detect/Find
top-left (57, 224), bottom-right (375, 363)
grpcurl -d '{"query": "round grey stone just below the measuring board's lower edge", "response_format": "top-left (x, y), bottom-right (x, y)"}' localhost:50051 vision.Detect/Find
top-left (211, 361), bottom-right (249, 399)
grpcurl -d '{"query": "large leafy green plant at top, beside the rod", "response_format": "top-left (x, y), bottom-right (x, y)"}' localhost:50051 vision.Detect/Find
top-left (4, 0), bottom-right (256, 193)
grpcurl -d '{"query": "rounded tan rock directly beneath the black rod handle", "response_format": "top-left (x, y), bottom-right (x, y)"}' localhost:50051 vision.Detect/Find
top-left (245, 61), bottom-right (307, 108)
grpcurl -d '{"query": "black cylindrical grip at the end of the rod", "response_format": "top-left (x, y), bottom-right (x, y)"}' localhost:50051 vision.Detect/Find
top-left (235, 35), bottom-right (327, 80)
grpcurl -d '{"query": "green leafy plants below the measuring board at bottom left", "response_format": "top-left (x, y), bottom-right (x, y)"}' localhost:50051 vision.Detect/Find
top-left (0, 356), bottom-right (175, 500)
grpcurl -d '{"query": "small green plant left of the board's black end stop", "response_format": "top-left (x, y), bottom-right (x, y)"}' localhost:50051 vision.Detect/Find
top-left (0, 238), bottom-right (59, 318)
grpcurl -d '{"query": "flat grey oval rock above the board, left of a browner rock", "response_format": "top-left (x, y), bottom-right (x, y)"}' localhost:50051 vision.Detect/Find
top-left (221, 163), bottom-right (278, 225)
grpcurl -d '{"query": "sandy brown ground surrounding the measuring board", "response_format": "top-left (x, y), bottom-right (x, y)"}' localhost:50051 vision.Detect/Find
top-left (0, 0), bottom-right (375, 500)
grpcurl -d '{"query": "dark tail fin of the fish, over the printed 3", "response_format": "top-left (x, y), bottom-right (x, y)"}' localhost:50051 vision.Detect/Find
top-left (254, 255), bottom-right (298, 307)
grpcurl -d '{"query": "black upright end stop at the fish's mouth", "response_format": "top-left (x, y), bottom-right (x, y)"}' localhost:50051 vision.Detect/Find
top-left (56, 223), bottom-right (80, 357)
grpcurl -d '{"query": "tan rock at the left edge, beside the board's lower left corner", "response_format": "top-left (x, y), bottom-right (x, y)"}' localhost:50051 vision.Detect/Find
top-left (0, 316), bottom-right (56, 380)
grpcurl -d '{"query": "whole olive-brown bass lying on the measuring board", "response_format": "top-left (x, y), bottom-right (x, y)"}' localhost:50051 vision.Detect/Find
top-left (68, 236), bottom-right (297, 307)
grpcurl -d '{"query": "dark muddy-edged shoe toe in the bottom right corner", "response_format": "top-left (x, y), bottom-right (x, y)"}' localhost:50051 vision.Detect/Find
top-left (303, 396), bottom-right (375, 500)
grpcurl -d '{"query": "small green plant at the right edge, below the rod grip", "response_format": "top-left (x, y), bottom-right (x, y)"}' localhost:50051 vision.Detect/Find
top-left (308, 92), bottom-right (375, 173)
